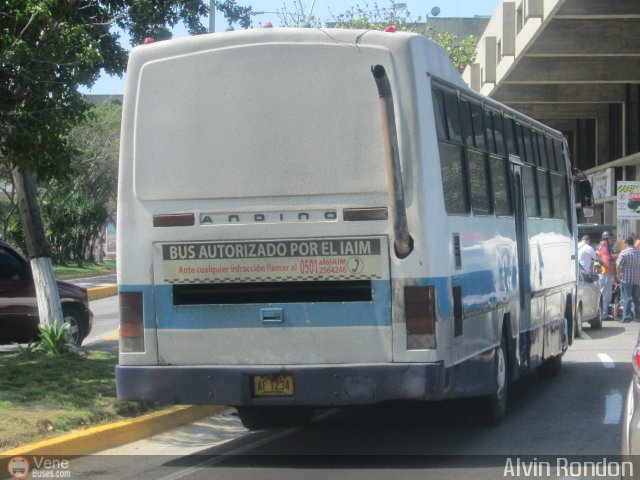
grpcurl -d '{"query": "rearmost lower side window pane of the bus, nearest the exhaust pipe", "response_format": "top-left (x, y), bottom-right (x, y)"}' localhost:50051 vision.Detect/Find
top-left (439, 142), bottom-right (469, 214)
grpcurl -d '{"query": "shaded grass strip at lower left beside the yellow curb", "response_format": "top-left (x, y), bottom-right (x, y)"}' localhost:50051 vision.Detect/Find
top-left (0, 351), bottom-right (160, 450)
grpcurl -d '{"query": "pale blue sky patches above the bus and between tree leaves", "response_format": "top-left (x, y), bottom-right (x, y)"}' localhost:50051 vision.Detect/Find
top-left (81, 0), bottom-right (500, 95)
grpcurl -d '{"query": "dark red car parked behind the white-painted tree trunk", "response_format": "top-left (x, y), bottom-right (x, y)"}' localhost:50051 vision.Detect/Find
top-left (0, 241), bottom-right (93, 345)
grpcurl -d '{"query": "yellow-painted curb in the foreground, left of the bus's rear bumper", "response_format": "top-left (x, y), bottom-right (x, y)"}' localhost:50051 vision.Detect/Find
top-left (0, 405), bottom-right (227, 457)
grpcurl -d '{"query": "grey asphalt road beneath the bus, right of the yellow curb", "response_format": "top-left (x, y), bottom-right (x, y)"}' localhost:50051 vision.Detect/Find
top-left (60, 316), bottom-right (640, 480)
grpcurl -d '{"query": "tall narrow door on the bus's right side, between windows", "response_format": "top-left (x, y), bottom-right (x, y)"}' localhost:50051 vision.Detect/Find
top-left (509, 155), bottom-right (532, 368)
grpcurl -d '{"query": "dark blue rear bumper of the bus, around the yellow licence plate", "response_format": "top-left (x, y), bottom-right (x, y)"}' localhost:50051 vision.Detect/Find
top-left (116, 362), bottom-right (445, 406)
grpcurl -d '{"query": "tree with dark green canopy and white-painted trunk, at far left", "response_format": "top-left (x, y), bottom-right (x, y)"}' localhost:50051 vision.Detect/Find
top-left (0, 0), bottom-right (250, 323)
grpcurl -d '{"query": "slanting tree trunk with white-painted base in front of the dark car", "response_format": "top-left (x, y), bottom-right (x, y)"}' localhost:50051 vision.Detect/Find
top-left (11, 167), bottom-right (63, 325)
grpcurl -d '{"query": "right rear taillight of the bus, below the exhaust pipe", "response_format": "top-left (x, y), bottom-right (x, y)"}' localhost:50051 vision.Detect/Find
top-left (404, 286), bottom-right (436, 348)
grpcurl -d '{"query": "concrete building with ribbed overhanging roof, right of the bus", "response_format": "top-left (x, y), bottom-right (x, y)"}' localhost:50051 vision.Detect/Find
top-left (463, 0), bottom-right (640, 232)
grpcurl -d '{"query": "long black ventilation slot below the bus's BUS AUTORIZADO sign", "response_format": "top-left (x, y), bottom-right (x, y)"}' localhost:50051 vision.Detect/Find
top-left (173, 280), bottom-right (372, 305)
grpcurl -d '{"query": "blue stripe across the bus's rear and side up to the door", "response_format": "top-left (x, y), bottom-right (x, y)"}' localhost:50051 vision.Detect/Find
top-left (119, 260), bottom-right (517, 329)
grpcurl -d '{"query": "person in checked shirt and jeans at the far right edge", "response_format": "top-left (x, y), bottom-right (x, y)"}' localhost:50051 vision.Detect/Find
top-left (616, 235), bottom-right (640, 323)
